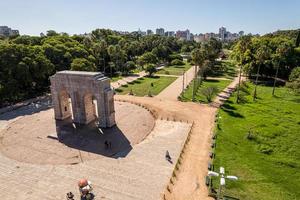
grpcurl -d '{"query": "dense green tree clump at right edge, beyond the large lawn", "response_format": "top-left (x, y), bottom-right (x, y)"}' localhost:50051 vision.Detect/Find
top-left (231, 32), bottom-right (300, 79)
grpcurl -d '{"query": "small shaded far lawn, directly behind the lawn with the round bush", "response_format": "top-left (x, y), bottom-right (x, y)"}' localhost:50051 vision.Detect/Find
top-left (207, 60), bottom-right (237, 79)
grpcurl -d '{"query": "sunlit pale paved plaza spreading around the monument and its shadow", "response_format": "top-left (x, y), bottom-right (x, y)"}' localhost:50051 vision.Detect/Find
top-left (0, 99), bottom-right (191, 200)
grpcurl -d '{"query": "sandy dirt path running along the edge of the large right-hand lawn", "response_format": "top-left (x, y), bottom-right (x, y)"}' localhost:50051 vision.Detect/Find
top-left (165, 72), bottom-right (244, 200)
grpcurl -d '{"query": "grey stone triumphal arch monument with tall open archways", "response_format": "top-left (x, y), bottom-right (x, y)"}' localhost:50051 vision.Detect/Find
top-left (50, 71), bottom-right (115, 128)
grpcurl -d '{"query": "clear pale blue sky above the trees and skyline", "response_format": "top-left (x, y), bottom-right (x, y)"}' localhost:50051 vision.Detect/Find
top-left (0, 0), bottom-right (300, 35)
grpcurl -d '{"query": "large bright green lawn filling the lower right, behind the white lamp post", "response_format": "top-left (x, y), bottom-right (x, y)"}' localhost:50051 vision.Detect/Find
top-left (214, 84), bottom-right (300, 200)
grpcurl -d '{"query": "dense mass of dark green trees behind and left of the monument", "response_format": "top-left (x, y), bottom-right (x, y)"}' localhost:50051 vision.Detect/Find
top-left (0, 29), bottom-right (196, 106)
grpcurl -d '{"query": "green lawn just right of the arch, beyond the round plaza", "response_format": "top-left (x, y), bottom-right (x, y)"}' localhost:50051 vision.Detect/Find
top-left (116, 76), bottom-right (176, 96)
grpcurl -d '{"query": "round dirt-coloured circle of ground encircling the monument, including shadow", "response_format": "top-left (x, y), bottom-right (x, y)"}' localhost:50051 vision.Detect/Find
top-left (0, 102), bottom-right (155, 165)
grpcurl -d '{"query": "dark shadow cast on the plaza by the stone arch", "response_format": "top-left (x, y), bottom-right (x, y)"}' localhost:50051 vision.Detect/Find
top-left (52, 118), bottom-right (132, 159)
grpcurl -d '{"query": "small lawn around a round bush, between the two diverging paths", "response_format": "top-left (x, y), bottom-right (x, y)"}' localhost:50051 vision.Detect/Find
top-left (181, 80), bottom-right (231, 103)
